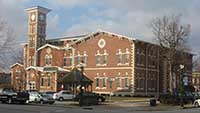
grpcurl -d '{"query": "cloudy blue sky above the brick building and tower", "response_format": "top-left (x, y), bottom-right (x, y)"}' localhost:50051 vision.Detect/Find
top-left (0, 0), bottom-right (200, 54)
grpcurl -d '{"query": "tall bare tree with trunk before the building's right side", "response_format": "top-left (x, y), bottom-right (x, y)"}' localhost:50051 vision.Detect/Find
top-left (150, 14), bottom-right (190, 94)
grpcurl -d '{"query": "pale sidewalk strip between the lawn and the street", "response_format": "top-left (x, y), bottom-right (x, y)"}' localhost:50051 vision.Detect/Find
top-left (54, 100), bottom-right (198, 111)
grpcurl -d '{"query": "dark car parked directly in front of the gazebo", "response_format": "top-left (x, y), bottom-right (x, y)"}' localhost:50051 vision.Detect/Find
top-left (74, 92), bottom-right (105, 105)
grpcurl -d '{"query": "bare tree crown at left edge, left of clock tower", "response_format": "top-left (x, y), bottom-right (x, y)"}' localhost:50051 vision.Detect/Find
top-left (0, 17), bottom-right (15, 71)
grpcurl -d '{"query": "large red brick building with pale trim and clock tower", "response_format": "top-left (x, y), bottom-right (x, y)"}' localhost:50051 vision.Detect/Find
top-left (11, 6), bottom-right (192, 95)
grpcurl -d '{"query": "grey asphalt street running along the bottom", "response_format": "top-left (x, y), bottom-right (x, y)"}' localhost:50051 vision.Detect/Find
top-left (0, 104), bottom-right (200, 113)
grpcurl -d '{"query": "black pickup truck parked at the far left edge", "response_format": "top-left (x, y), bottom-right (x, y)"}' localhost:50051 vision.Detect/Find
top-left (0, 88), bottom-right (29, 104)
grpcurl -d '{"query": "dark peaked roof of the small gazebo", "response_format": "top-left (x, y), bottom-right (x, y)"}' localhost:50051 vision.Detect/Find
top-left (62, 68), bottom-right (93, 85)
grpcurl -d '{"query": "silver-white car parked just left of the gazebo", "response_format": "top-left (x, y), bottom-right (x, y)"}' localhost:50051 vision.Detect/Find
top-left (53, 90), bottom-right (75, 101)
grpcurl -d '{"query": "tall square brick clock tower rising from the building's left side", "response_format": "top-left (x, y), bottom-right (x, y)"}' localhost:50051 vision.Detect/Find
top-left (26, 6), bottom-right (50, 66)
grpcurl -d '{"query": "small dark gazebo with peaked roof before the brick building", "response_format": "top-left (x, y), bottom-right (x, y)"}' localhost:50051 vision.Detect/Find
top-left (61, 68), bottom-right (93, 94)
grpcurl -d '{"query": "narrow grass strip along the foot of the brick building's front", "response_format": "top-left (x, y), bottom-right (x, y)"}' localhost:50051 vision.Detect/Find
top-left (106, 96), bottom-right (150, 101)
